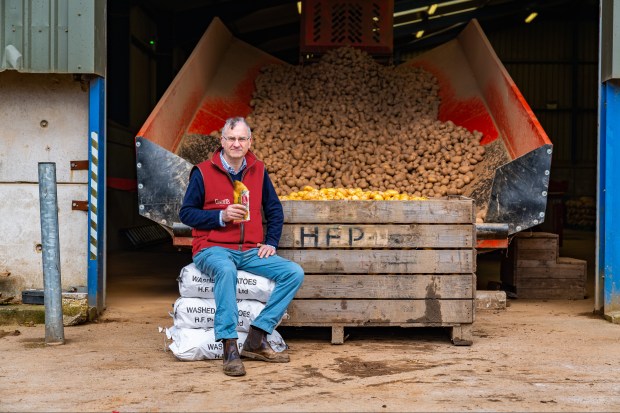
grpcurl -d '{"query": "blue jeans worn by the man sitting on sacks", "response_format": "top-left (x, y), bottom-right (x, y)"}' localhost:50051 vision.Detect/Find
top-left (194, 247), bottom-right (304, 340)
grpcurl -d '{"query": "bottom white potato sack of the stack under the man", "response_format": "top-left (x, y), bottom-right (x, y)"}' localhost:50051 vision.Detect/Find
top-left (160, 327), bottom-right (288, 361)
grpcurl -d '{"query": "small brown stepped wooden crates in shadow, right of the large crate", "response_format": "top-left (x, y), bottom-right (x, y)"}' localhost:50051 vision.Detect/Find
top-left (501, 232), bottom-right (588, 299)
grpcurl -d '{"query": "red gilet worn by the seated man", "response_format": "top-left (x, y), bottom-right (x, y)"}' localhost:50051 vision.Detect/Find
top-left (192, 149), bottom-right (265, 255)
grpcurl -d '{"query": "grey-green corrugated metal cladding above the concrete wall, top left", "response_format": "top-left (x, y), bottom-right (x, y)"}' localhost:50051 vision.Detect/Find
top-left (0, 0), bottom-right (106, 76)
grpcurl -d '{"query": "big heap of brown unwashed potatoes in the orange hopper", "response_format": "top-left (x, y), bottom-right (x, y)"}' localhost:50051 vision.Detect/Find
top-left (220, 47), bottom-right (485, 197)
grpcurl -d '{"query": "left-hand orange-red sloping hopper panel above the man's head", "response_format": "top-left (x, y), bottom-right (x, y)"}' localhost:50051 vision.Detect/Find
top-left (137, 18), bottom-right (283, 153)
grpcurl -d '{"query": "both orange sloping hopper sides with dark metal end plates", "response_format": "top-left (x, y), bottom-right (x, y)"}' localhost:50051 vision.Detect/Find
top-left (136, 18), bottom-right (552, 238)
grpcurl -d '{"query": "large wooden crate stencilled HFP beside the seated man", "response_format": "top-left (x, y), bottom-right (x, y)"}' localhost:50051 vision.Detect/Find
top-left (278, 197), bottom-right (476, 345)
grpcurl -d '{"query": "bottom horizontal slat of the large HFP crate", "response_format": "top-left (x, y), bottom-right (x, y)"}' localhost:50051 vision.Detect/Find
top-left (282, 299), bottom-right (474, 326)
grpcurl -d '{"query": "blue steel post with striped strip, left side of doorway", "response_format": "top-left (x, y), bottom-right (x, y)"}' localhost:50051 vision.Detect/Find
top-left (87, 77), bottom-right (106, 312)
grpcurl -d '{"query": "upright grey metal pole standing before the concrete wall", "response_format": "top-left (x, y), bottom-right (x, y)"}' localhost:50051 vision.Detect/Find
top-left (39, 162), bottom-right (65, 344)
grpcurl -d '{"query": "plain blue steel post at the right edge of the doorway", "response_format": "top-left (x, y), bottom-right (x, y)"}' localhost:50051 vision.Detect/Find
top-left (597, 79), bottom-right (620, 322)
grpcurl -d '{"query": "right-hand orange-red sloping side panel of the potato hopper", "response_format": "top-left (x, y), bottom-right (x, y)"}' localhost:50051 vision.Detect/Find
top-left (405, 20), bottom-right (551, 159)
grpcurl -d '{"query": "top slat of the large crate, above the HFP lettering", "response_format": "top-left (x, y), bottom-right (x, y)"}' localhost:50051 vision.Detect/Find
top-left (282, 199), bottom-right (474, 224)
